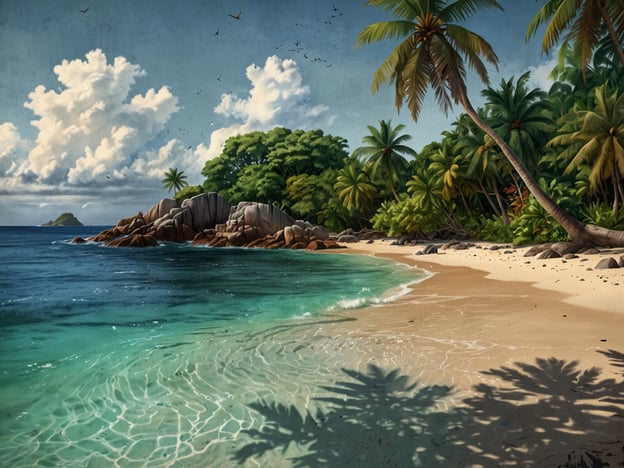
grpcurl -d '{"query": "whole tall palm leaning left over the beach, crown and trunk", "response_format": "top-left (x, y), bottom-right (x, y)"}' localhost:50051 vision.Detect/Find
top-left (357, 0), bottom-right (624, 245)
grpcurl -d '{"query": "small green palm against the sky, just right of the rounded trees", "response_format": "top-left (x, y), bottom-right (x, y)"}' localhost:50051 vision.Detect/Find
top-left (353, 120), bottom-right (416, 201)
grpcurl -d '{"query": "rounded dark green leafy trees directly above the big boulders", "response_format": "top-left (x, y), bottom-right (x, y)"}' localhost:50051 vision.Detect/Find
top-left (202, 127), bottom-right (348, 222)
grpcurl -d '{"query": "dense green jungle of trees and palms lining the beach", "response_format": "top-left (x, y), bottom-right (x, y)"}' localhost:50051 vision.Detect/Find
top-left (168, 0), bottom-right (624, 243)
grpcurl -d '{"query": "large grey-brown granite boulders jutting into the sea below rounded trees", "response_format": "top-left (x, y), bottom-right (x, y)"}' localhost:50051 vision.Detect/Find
top-left (90, 193), bottom-right (339, 250)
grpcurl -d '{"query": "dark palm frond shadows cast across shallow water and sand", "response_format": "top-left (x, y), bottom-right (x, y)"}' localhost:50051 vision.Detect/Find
top-left (233, 350), bottom-right (624, 468)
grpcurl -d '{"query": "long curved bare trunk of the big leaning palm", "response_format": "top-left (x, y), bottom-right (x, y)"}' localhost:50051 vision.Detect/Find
top-left (459, 88), bottom-right (624, 247)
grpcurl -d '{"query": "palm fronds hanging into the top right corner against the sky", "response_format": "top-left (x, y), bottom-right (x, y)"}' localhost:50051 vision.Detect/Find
top-left (526, 0), bottom-right (624, 72)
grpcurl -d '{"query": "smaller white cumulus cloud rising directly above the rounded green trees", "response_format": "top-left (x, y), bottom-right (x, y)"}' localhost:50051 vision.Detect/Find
top-left (204, 55), bottom-right (332, 160)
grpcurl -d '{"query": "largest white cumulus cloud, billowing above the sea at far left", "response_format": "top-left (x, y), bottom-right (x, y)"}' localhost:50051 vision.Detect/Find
top-left (0, 49), bottom-right (189, 189)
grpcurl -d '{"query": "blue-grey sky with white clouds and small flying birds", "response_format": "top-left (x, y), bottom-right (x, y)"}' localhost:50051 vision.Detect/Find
top-left (0, 0), bottom-right (554, 226)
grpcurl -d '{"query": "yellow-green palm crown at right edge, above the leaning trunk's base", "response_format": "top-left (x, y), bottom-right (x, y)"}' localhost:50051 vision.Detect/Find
top-left (550, 85), bottom-right (624, 214)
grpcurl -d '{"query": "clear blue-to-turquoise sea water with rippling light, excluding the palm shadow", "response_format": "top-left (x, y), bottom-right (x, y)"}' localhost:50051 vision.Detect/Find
top-left (0, 227), bottom-right (424, 466)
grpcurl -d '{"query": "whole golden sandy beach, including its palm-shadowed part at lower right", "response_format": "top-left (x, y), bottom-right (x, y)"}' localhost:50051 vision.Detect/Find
top-left (310, 240), bottom-right (624, 467)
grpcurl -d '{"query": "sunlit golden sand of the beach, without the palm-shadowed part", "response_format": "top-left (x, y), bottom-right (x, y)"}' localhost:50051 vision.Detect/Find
top-left (324, 241), bottom-right (624, 392)
